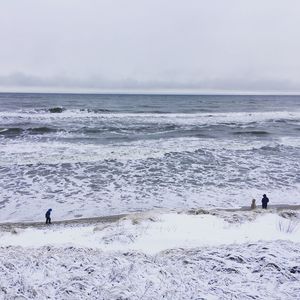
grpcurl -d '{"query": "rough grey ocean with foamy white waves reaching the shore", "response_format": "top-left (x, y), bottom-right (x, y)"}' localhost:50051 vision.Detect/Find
top-left (0, 93), bottom-right (300, 221)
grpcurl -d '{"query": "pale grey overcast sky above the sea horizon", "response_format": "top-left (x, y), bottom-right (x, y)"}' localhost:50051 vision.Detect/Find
top-left (0, 0), bottom-right (300, 92)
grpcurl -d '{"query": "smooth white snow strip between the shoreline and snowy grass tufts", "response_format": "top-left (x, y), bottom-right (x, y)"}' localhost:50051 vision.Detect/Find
top-left (0, 213), bottom-right (300, 254)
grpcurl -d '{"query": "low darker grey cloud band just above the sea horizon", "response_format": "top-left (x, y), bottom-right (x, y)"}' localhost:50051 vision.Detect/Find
top-left (0, 73), bottom-right (300, 92)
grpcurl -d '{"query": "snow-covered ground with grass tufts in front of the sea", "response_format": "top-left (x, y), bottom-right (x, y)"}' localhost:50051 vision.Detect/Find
top-left (0, 210), bottom-right (300, 299)
